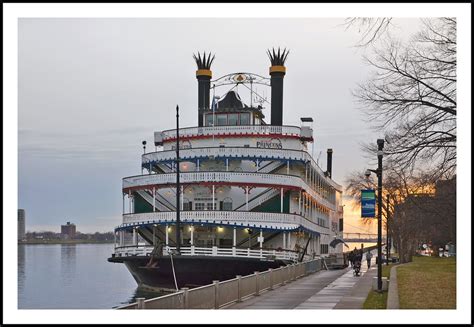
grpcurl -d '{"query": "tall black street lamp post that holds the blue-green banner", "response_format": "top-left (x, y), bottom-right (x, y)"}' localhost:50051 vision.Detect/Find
top-left (365, 139), bottom-right (388, 292)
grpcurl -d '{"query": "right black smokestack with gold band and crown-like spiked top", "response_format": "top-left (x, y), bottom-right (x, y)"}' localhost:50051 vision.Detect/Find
top-left (267, 48), bottom-right (290, 126)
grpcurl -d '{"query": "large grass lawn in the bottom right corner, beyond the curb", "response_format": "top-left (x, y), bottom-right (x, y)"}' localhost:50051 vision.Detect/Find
top-left (397, 257), bottom-right (456, 309)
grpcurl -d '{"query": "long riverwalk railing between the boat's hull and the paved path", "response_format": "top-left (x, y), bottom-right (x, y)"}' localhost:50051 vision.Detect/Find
top-left (117, 258), bottom-right (328, 309)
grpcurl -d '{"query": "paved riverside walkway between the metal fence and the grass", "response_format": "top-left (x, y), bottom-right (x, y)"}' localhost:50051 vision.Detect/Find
top-left (225, 255), bottom-right (377, 309)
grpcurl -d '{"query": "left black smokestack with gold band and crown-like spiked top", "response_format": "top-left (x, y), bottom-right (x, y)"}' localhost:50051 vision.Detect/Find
top-left (193, 52), bottom-right (215, 127)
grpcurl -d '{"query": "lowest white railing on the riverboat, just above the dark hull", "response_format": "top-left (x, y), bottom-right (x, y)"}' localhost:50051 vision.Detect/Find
top-left (115, 245), bottom-right (298, 261)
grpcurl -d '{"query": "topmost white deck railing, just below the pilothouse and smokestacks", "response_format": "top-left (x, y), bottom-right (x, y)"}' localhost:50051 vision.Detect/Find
top-left (162, 125), bottom-right (301, 142)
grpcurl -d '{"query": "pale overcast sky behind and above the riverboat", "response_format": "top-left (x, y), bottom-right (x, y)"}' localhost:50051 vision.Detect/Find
top-left (18, 18), bottom-right (419, 232)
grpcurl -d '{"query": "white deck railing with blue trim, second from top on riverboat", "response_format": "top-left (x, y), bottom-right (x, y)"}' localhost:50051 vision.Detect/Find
top-left (142, 147), bottom-right (342, 191)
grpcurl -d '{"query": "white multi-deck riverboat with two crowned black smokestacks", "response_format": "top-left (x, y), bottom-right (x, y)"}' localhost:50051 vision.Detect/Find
top-left (108, 49), bottom-right (343, 290)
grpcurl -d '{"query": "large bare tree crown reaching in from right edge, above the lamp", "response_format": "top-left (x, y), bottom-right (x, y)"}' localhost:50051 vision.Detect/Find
top-left (353, 18), bottom-right (457, 178)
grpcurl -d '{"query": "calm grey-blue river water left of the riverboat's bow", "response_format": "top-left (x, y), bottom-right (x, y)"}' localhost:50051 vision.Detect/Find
top-left (18, 244), bottom-right (162, 309)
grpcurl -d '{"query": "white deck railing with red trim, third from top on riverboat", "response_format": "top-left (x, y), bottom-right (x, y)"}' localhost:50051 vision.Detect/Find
top-left (122, 172), bottom-right (336, 210)
